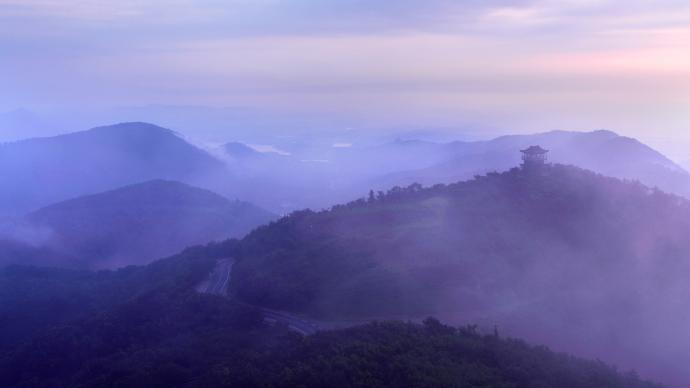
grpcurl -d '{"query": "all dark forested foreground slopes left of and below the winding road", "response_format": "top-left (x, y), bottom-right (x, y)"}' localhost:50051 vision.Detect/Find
top-left (0, 249), bottom-right (660, 388)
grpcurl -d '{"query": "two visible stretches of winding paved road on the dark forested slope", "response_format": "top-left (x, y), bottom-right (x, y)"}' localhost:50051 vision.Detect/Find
top-left (196, 258), bottom-right (319, 335)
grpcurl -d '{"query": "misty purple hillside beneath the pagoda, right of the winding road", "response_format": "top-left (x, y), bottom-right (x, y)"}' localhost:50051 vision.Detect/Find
top-left (231, 165), bottom-right (690, 383)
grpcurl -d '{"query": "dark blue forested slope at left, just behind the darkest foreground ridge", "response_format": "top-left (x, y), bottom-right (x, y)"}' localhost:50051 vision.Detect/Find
top-left (0, 245), bottom-right (217, 349)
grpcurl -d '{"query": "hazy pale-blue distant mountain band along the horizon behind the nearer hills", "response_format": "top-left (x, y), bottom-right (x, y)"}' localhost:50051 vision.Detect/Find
top-left (0, 122), bottom-right (690, 217)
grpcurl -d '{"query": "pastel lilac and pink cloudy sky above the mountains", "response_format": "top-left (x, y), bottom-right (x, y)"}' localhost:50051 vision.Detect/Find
top-left (0, 0), bottom-right (690, 160)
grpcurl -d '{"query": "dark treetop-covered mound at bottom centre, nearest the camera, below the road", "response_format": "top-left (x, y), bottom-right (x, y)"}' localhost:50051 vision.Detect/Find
top-left (194, 318), bottom-right (658, 388)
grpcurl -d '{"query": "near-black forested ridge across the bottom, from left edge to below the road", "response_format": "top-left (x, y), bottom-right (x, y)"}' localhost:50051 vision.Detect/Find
top-left (0, 268), bottom-right (658, 388)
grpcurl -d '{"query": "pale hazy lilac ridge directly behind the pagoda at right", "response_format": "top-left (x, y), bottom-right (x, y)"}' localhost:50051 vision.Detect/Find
top-left (378, 130), bottom-right (690, 196)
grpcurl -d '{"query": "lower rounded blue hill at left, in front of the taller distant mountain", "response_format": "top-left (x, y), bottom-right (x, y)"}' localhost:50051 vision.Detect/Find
top-left (26, 180), bottom-right (274, 268)
